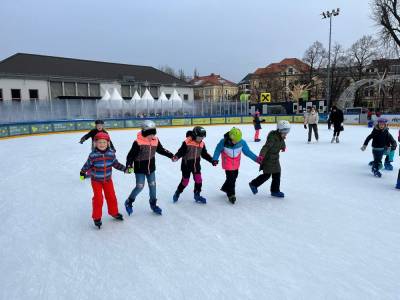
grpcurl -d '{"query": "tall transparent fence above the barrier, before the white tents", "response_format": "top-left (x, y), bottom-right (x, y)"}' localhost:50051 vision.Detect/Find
top-left (0, 99), bottom-right (249, 124)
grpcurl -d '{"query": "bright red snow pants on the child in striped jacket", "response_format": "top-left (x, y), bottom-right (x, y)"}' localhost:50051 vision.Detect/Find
top-left (92, 179), bottom-right (118, 220)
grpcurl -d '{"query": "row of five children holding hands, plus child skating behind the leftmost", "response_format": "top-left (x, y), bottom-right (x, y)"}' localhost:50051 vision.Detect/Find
top-left (80, 120), bottom-right (290, 229)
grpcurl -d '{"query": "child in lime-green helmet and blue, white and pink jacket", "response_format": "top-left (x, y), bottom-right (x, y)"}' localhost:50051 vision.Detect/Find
top-left (213, 127), bottom-right (258, 204)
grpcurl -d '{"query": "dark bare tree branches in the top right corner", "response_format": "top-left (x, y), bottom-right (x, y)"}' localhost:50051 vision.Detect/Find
top-left (371, 0), bottom-right (400, 57)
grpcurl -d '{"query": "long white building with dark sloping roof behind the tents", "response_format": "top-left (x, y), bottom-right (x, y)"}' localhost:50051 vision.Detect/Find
top-left (0, 53), bottom-right (194, 101)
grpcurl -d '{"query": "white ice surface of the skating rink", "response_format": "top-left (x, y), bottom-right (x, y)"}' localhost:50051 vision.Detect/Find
top-left (0, 125), bottom-right (400, 300)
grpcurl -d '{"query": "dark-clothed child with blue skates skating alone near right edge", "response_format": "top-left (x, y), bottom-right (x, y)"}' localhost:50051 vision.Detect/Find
top-left (361, 118), bottom-right (391, 177)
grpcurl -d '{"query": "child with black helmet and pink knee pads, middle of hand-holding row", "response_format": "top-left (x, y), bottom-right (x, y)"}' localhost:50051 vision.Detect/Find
top-left (173, 126), bottom-right (216, 204)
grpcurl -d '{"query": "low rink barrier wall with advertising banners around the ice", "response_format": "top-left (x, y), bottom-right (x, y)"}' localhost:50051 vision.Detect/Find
top-left (0, 114), bottom-right (384, 138)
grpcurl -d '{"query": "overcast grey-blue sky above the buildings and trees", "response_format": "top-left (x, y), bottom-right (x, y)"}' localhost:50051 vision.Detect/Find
top-left (0, 0), bottom-right (377, 82)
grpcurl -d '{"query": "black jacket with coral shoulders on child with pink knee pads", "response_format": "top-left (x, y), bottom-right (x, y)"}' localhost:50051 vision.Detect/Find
top-left (175, 131), bottom-right (212, 173)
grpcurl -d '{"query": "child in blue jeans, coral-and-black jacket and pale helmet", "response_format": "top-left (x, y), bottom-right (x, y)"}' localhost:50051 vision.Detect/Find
top-left (125, 120), bottom-right (173, 215)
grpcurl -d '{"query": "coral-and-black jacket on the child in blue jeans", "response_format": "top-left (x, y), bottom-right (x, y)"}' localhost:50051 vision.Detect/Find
top-left (126, 132), bottom-right (173, 174)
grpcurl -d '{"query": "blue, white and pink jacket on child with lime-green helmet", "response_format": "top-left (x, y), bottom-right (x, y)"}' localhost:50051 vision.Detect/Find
top-left (213, 132), bottom-right (257, 171)
